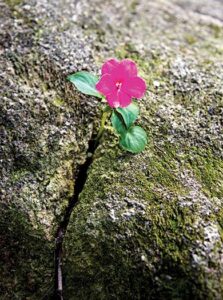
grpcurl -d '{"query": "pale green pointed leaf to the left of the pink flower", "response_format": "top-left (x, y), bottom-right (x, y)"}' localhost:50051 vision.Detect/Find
top-left (67, 71), bottom-right (103, 98)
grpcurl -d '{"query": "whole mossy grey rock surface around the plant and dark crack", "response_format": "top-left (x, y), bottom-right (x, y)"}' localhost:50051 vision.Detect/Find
top-left (0, 0), bottom-right (223, 299)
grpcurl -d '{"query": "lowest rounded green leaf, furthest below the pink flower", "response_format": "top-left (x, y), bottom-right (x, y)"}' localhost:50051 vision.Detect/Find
top-left (120, 126), bottom-right (147, 153)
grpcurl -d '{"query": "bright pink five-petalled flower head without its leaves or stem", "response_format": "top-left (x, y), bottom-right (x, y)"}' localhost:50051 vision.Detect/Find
top-left (96, 59), bottom-right (146, 107)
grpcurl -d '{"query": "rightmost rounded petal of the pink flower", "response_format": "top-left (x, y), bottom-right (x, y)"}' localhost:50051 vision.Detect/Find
top-left (122, 76), bottom-right (146, 98)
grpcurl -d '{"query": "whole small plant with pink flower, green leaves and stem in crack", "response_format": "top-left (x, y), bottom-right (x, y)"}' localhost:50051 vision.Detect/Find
top-left (68, 59), bottom-right (147, 153)
